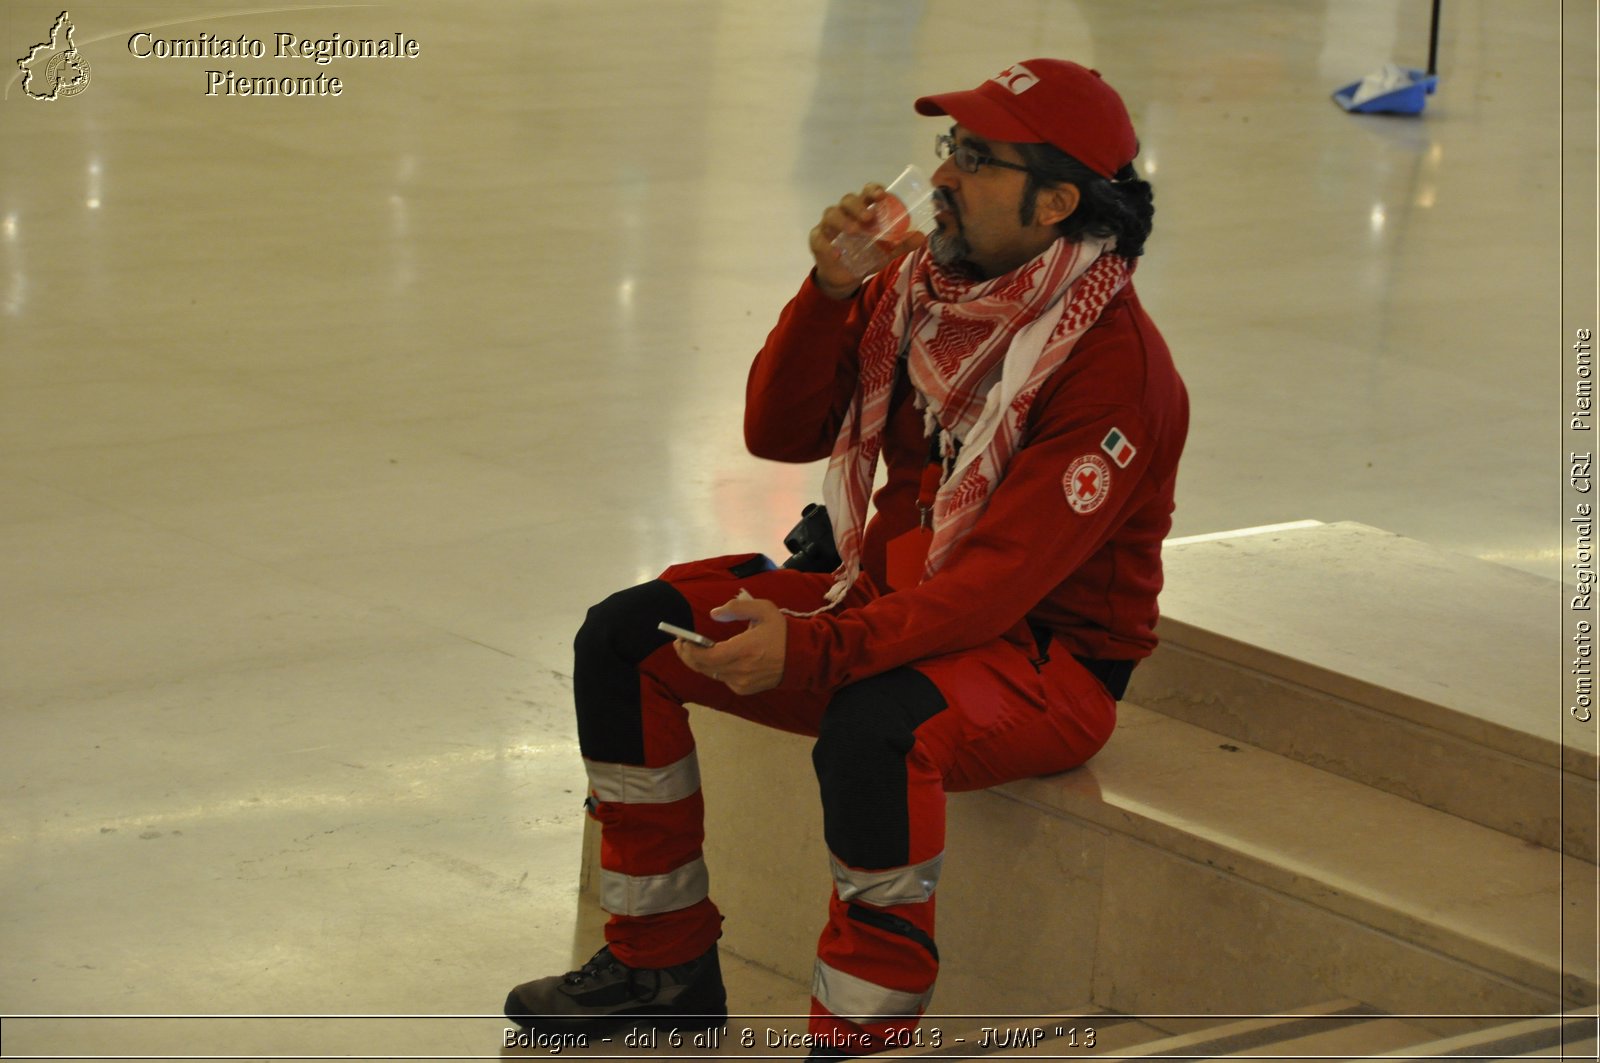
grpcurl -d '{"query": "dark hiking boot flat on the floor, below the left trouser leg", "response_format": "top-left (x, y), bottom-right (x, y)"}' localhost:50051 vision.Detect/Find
top-left (506, 945), bottom-right (728, 1033)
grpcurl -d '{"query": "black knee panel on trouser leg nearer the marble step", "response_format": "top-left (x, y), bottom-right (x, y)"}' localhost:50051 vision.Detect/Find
top-left (811, 668), bottom-right (947, 868)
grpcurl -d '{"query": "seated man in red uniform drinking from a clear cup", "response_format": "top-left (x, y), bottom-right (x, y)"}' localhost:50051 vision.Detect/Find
top-left (506, 59), bottom-right (1189, 1058)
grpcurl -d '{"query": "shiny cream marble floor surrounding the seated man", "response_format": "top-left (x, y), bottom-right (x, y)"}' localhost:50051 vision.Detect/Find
top-left (0, 0), bottom-right (1595, 1055)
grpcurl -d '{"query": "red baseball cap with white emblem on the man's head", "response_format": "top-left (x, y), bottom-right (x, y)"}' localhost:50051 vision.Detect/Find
top-left (917, 59), bottom-right (1139, 178)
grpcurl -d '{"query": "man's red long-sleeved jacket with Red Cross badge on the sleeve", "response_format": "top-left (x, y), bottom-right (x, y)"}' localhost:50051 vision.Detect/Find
top-left (744, 271), bottom-right (1189, 693)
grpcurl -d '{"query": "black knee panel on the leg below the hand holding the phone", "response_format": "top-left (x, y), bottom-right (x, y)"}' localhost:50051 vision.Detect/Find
top-left (573, 580), bottom-right (694, 764)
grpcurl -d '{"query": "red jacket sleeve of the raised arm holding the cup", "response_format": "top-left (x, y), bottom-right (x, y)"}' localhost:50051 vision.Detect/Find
top-left (744, 271), bottom-right (890, 463)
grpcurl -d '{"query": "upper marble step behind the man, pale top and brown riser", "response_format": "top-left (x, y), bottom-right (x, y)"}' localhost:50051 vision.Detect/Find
top-left (1128, 522), bottom-right (1600, 861)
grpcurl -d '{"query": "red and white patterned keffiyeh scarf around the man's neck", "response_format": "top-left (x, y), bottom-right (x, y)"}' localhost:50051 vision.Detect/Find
top-left (800, 240), bottom-right (1133, 608)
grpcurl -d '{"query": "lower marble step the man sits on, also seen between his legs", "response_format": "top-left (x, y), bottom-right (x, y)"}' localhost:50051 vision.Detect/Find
top-left (574, 694), bottom-right (1597, 1033)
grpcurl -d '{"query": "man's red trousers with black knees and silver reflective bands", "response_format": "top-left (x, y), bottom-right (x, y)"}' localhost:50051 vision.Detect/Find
top-left (573, 556), bottom-right (1115, 1055)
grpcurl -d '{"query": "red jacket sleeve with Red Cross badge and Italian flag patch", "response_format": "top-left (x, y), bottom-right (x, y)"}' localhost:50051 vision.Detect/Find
top-left (782, 395), bottom-right (1158, 693)
